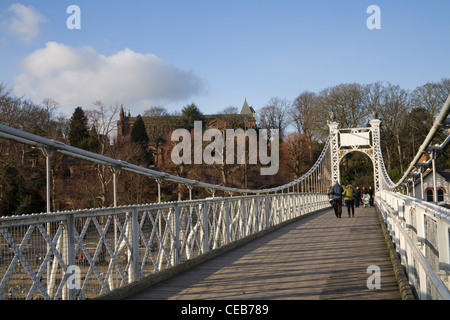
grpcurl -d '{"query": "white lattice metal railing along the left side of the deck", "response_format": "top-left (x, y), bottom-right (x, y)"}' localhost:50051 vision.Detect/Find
top-left (0, 193), bottom-right (329, 299)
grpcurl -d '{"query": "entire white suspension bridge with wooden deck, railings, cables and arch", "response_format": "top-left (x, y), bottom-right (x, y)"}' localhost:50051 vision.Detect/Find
top-left (0, 97), bottom-right (450, 300)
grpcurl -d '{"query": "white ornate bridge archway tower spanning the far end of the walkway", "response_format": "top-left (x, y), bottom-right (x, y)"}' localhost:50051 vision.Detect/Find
top-left (328, 117), bottom-right (382, 192)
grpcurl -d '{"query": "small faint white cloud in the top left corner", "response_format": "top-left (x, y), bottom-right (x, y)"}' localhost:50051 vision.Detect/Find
top-left (4, 3), bottom-right (45, 43)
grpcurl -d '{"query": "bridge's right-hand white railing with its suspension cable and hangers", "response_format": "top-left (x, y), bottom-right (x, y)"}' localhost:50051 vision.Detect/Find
top-left (375, 95), bottom-right (450, 300)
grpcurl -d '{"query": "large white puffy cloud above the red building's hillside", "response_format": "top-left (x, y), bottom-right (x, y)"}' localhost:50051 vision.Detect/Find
top-left (14, 42), bottom-right (205, 112)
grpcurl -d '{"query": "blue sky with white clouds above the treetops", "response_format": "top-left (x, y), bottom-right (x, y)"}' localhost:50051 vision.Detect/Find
top-left (0, 0), bottom-right (450, 115)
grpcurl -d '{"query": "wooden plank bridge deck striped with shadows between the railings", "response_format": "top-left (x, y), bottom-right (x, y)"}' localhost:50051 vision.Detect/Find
top-left (128, 207), bottom-right (401, 300)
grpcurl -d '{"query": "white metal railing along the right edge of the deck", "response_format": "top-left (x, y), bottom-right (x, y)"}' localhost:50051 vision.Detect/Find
top-left (376, 191), bottom-right (450, 300)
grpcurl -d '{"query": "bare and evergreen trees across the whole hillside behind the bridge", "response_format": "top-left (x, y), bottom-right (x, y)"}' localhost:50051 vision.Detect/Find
top-left (0, 79), bottom-right (450, 215)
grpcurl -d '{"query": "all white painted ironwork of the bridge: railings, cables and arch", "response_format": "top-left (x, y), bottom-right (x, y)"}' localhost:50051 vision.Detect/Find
top-left (0, 96), bottom-right (450, 299)
